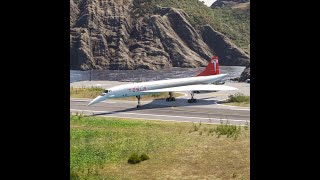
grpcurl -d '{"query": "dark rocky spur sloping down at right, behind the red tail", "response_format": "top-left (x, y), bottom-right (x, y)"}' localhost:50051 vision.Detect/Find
top-left (202, 25), bottom-right (250, 66)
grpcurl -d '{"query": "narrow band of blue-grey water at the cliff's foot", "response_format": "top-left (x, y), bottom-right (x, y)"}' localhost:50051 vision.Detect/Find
top-left (70, 66), bottom-right (245, 83)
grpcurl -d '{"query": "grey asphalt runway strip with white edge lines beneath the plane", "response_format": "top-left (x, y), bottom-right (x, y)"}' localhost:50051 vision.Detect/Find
top-left (70, 98), bottom-right (250, 125)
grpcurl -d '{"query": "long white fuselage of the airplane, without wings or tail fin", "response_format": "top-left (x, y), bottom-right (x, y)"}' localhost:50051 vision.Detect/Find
top-left (90, 74), bottom-right (227, 104)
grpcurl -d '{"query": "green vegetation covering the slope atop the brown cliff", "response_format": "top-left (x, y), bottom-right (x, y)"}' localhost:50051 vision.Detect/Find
top-left (133, 0), bottom-right (250, 54)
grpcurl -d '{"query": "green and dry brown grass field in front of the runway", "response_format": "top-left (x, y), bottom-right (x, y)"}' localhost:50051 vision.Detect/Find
top-left (70, 115), bottom-right (250, 179)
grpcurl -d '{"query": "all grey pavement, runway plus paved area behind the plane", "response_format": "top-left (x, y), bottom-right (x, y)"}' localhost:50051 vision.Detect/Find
top-left (70, 81), bottom-right (250, 125)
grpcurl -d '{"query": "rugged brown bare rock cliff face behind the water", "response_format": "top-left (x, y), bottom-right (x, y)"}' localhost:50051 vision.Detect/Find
top-left (70, 0), bottom-right (249, 70)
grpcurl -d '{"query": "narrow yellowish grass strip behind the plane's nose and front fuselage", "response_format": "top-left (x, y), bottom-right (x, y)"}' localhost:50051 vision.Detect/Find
top-left (70, 87), bottom-right (184, 101)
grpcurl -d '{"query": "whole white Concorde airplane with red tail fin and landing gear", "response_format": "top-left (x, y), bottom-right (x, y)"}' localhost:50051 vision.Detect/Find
top-left (88, 56), bottom-right (237, 108)
